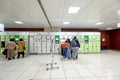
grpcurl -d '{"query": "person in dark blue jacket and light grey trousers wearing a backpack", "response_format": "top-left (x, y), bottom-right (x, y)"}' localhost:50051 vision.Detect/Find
top-left (71, 37), bottom-right (80, 60)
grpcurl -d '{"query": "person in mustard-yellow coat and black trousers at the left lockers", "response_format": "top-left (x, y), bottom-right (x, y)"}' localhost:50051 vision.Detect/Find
top-left (17, 38), bottom-right (25, 59)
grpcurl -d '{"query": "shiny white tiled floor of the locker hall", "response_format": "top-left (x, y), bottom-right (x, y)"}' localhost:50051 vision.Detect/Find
top-left (0, 51), bottom-right (120, 80)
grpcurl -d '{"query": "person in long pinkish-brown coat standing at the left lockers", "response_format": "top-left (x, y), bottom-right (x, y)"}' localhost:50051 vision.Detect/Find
top-left (6, 39), bottom-right (16, 60)
